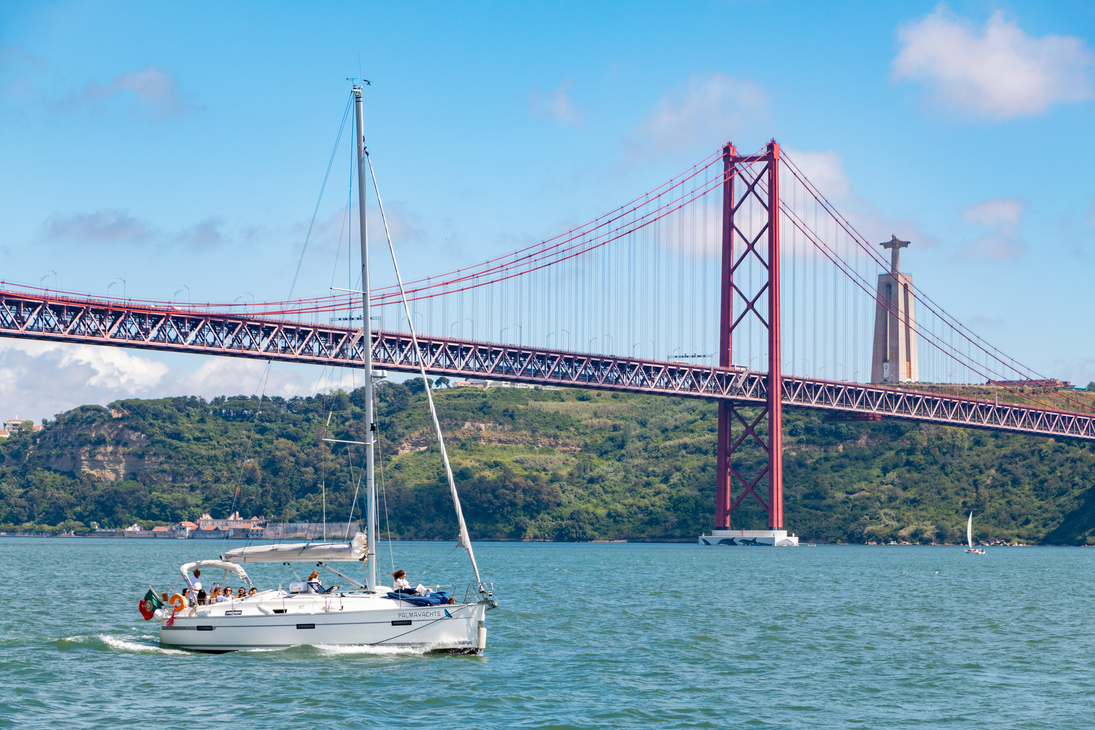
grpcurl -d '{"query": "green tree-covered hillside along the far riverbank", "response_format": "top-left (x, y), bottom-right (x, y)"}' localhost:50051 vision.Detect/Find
top-left (0, 380), bottom-right (1095, 544)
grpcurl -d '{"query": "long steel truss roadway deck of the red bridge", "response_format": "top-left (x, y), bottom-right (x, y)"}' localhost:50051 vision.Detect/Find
top-left (0, 291), bottom-right (1095, 440)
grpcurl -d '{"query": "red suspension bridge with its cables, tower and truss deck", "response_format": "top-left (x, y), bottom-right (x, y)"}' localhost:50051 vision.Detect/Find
top-left (0, 141), bottom-right (1095, 542)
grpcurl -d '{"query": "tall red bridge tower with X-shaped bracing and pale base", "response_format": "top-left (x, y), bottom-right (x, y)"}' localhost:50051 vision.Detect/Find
top-left (700, 140), bottom-right (798, 546)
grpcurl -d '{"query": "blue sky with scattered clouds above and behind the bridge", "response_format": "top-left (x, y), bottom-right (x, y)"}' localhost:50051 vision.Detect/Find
top-left (0, 0), bottom-right (1095, 420)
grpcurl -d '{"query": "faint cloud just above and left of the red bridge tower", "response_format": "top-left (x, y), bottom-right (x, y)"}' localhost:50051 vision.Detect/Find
top-left (629, 73), bottom-right (768, 157)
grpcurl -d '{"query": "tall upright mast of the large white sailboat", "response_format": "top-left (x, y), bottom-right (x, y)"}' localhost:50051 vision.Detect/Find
top-left (354, 85), bottom-right (377, 591)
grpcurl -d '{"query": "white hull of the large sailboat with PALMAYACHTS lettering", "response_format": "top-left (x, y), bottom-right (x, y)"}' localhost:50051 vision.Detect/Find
top-left (160, 592), bottom-right (488, 653)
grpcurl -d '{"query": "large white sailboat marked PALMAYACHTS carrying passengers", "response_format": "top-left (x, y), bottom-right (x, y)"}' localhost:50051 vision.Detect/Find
top-left (140, 85), bottom-right (497, 653)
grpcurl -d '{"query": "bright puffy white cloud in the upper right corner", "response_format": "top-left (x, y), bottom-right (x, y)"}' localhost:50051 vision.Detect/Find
top-left (894, 4), bottom-right (1095, 119)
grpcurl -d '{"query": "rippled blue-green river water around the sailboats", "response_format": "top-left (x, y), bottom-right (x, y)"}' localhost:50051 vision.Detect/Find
top-left (0, 538), bottom-right (1095, 728)
